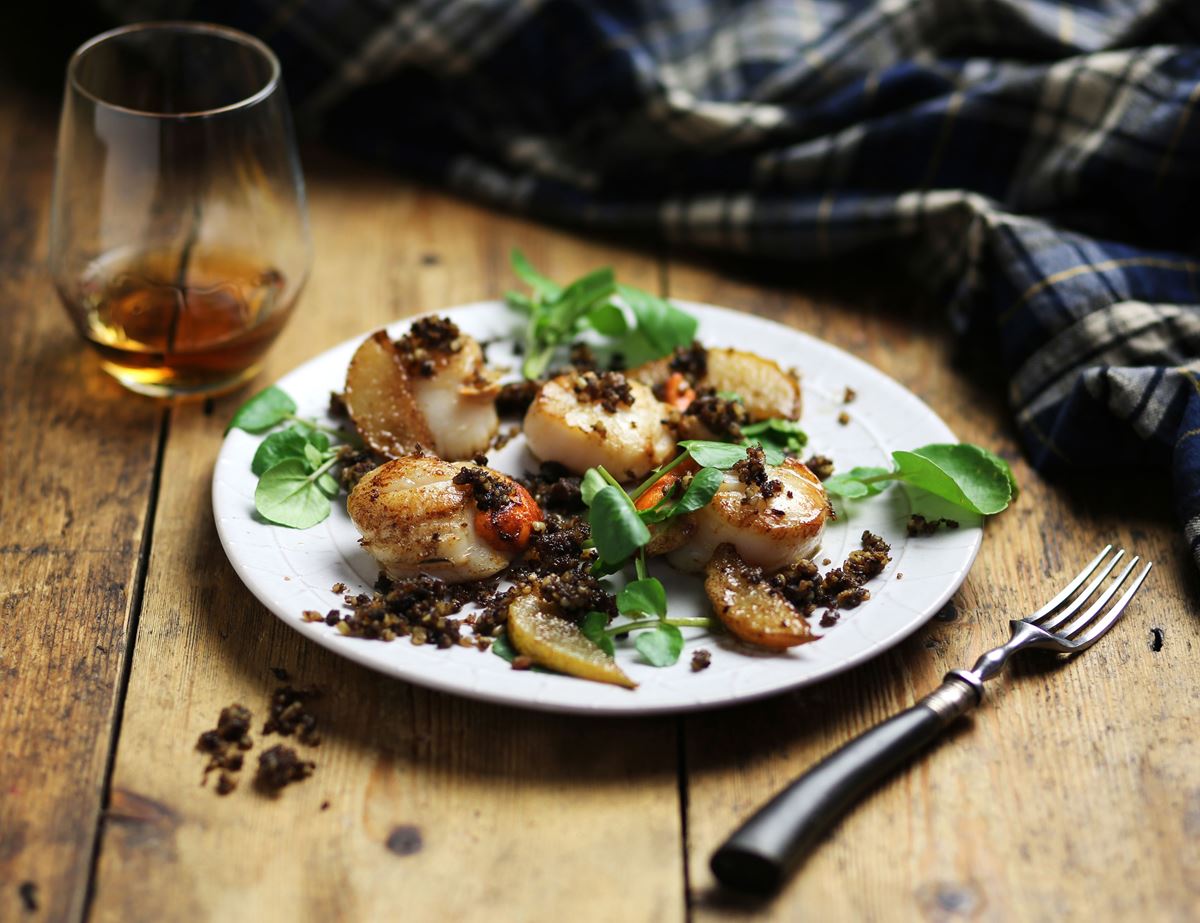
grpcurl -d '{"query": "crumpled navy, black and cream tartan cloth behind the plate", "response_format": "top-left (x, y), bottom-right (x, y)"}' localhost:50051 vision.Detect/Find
top-left (108, 0), bottom-right (1200, 554)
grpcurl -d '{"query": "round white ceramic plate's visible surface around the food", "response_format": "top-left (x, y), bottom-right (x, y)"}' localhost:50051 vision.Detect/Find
top-left (212, 302), bottom-right (983, 714)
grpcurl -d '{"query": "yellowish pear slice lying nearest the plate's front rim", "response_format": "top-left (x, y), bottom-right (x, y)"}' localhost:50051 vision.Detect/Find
top-left (506, 593), bottom-right (637, 689)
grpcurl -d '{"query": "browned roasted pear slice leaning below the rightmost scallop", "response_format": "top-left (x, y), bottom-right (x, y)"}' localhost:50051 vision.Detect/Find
top-left (704, 545), bottom-right (817, 649)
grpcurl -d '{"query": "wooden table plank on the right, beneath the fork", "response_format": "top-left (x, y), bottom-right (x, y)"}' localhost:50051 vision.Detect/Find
top-left (668, 255), bottom-right (1200, 921)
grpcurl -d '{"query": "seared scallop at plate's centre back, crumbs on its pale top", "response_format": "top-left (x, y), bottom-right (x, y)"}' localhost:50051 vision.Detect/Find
top-left (524, 372), bottom-right (674, 481)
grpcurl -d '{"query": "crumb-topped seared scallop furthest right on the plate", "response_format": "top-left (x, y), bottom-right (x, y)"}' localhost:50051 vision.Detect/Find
top-left (667, 448), bottom-right (829, 571)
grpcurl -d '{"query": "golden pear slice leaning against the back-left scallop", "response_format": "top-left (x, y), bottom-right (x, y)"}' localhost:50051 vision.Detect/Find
top-left (344, 330), bottom-right (433, 458)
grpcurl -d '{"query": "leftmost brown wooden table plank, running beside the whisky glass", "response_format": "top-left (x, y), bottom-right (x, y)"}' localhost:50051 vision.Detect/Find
top-left (0, 89), bottom-right (162, 919)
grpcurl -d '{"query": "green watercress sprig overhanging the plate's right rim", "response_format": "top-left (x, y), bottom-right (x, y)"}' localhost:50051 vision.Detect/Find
top-left (824, 443), bottom-right (1016, 516)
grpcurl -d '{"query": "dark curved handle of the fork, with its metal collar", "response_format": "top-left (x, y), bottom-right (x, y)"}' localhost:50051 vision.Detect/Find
top-left (712, 673), bottom-right (982, 894)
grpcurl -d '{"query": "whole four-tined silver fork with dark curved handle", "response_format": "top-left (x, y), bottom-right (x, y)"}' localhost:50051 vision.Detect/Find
top-left (710, 545), bottom-right (1153, 894)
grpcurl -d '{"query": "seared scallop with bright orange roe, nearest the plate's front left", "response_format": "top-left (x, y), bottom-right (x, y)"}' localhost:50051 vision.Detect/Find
top-left (346, 456), bottom-right (542, 583)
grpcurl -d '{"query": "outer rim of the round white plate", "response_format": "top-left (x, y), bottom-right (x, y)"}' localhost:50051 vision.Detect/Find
top-left (210, 298), bottom-right (984, 718)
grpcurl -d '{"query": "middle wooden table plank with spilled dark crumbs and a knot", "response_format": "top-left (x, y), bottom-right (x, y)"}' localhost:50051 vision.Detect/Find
top-left (87, 154), bottom-right (684, 921)
